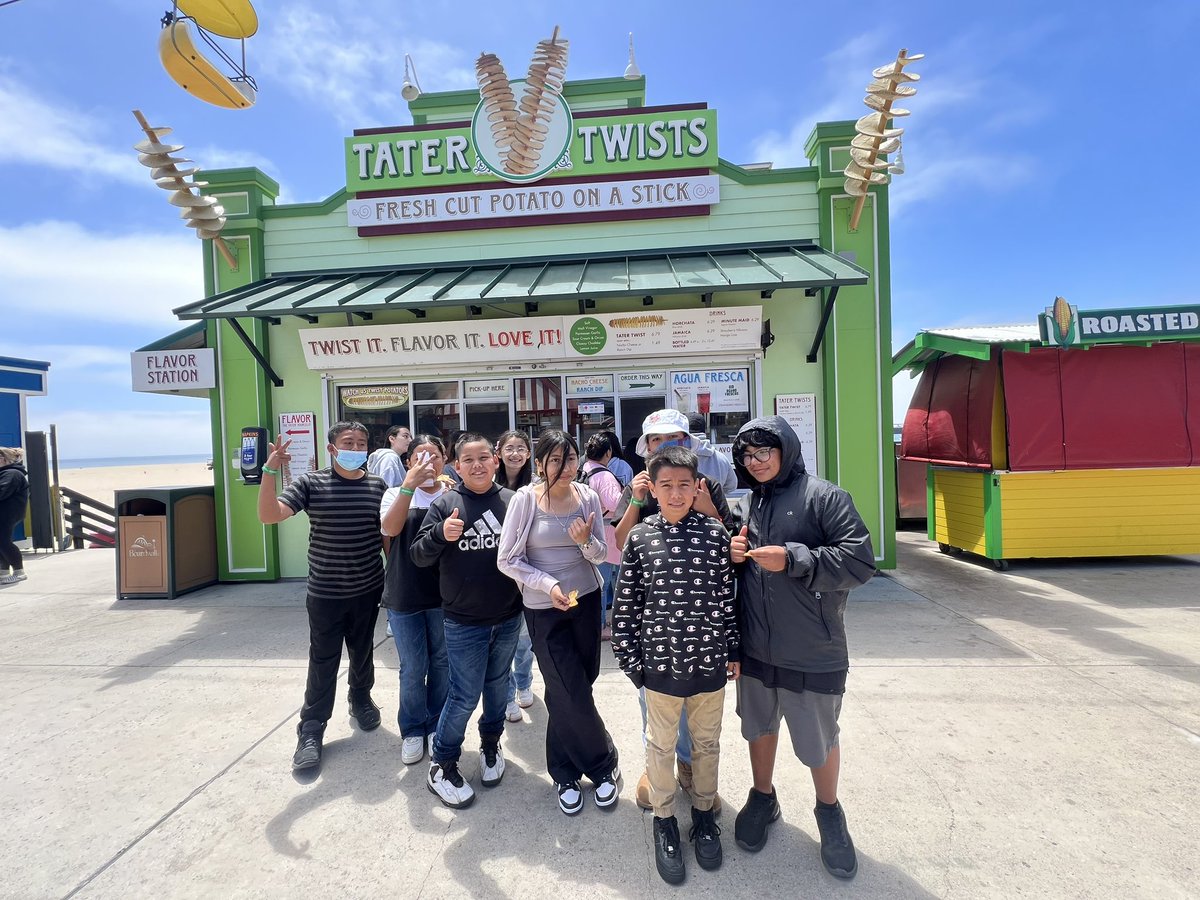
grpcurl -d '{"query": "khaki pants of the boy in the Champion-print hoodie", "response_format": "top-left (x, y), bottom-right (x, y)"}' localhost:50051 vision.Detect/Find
top-left (646, 685), bottom-right (725, 818)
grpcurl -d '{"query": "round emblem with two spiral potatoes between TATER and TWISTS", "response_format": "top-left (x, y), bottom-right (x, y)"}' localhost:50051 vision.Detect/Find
top-left (470, 28), bottom-right (571, 184)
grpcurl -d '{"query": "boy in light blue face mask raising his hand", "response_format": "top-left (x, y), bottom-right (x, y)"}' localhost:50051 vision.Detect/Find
top-left (258, 422), bottom-right (388, 770)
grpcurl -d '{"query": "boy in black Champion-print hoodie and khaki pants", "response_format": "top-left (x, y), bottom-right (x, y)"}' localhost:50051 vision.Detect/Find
top-left (612, 446), bottom-right (739, 884)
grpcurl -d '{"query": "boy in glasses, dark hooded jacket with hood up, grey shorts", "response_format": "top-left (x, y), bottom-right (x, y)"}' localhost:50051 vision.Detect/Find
top-left (730, 415), bottom-right (875, 878)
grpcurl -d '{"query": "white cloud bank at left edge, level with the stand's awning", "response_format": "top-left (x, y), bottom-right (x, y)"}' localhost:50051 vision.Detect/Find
top-left (0, 220), bottom-right (204, 331)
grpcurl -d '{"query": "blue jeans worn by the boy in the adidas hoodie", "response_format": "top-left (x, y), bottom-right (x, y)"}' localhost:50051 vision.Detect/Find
top-left (433, 613), bottom-right (521, 762)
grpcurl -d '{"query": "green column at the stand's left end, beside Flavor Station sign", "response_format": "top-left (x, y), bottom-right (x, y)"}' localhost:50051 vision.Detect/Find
top-left (204, 168), bottom-right (280, 581)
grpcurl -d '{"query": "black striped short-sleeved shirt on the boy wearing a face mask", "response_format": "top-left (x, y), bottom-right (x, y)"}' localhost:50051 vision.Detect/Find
top-left (280, 467), bottom-right (388, 600)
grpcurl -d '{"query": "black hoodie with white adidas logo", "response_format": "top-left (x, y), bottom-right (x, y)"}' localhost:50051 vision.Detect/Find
top-left (409, 482), bottom-right (521, 625)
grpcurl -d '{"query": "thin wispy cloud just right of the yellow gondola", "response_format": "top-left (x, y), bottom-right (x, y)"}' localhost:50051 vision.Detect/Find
top-left (254, 4), bottom-right (475, 127)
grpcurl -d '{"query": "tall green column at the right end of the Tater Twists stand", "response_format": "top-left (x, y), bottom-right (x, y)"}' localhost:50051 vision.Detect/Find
top-left (805, 121), bottom-right (896, 569)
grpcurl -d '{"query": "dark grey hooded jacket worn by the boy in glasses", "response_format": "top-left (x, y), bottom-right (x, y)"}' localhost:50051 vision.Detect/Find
top-left (734, 415), bottom-right (875, 673)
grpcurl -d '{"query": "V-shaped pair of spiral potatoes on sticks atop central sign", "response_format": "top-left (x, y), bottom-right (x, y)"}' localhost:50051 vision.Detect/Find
top-left (475, 28), bottom-right (568, 175)
